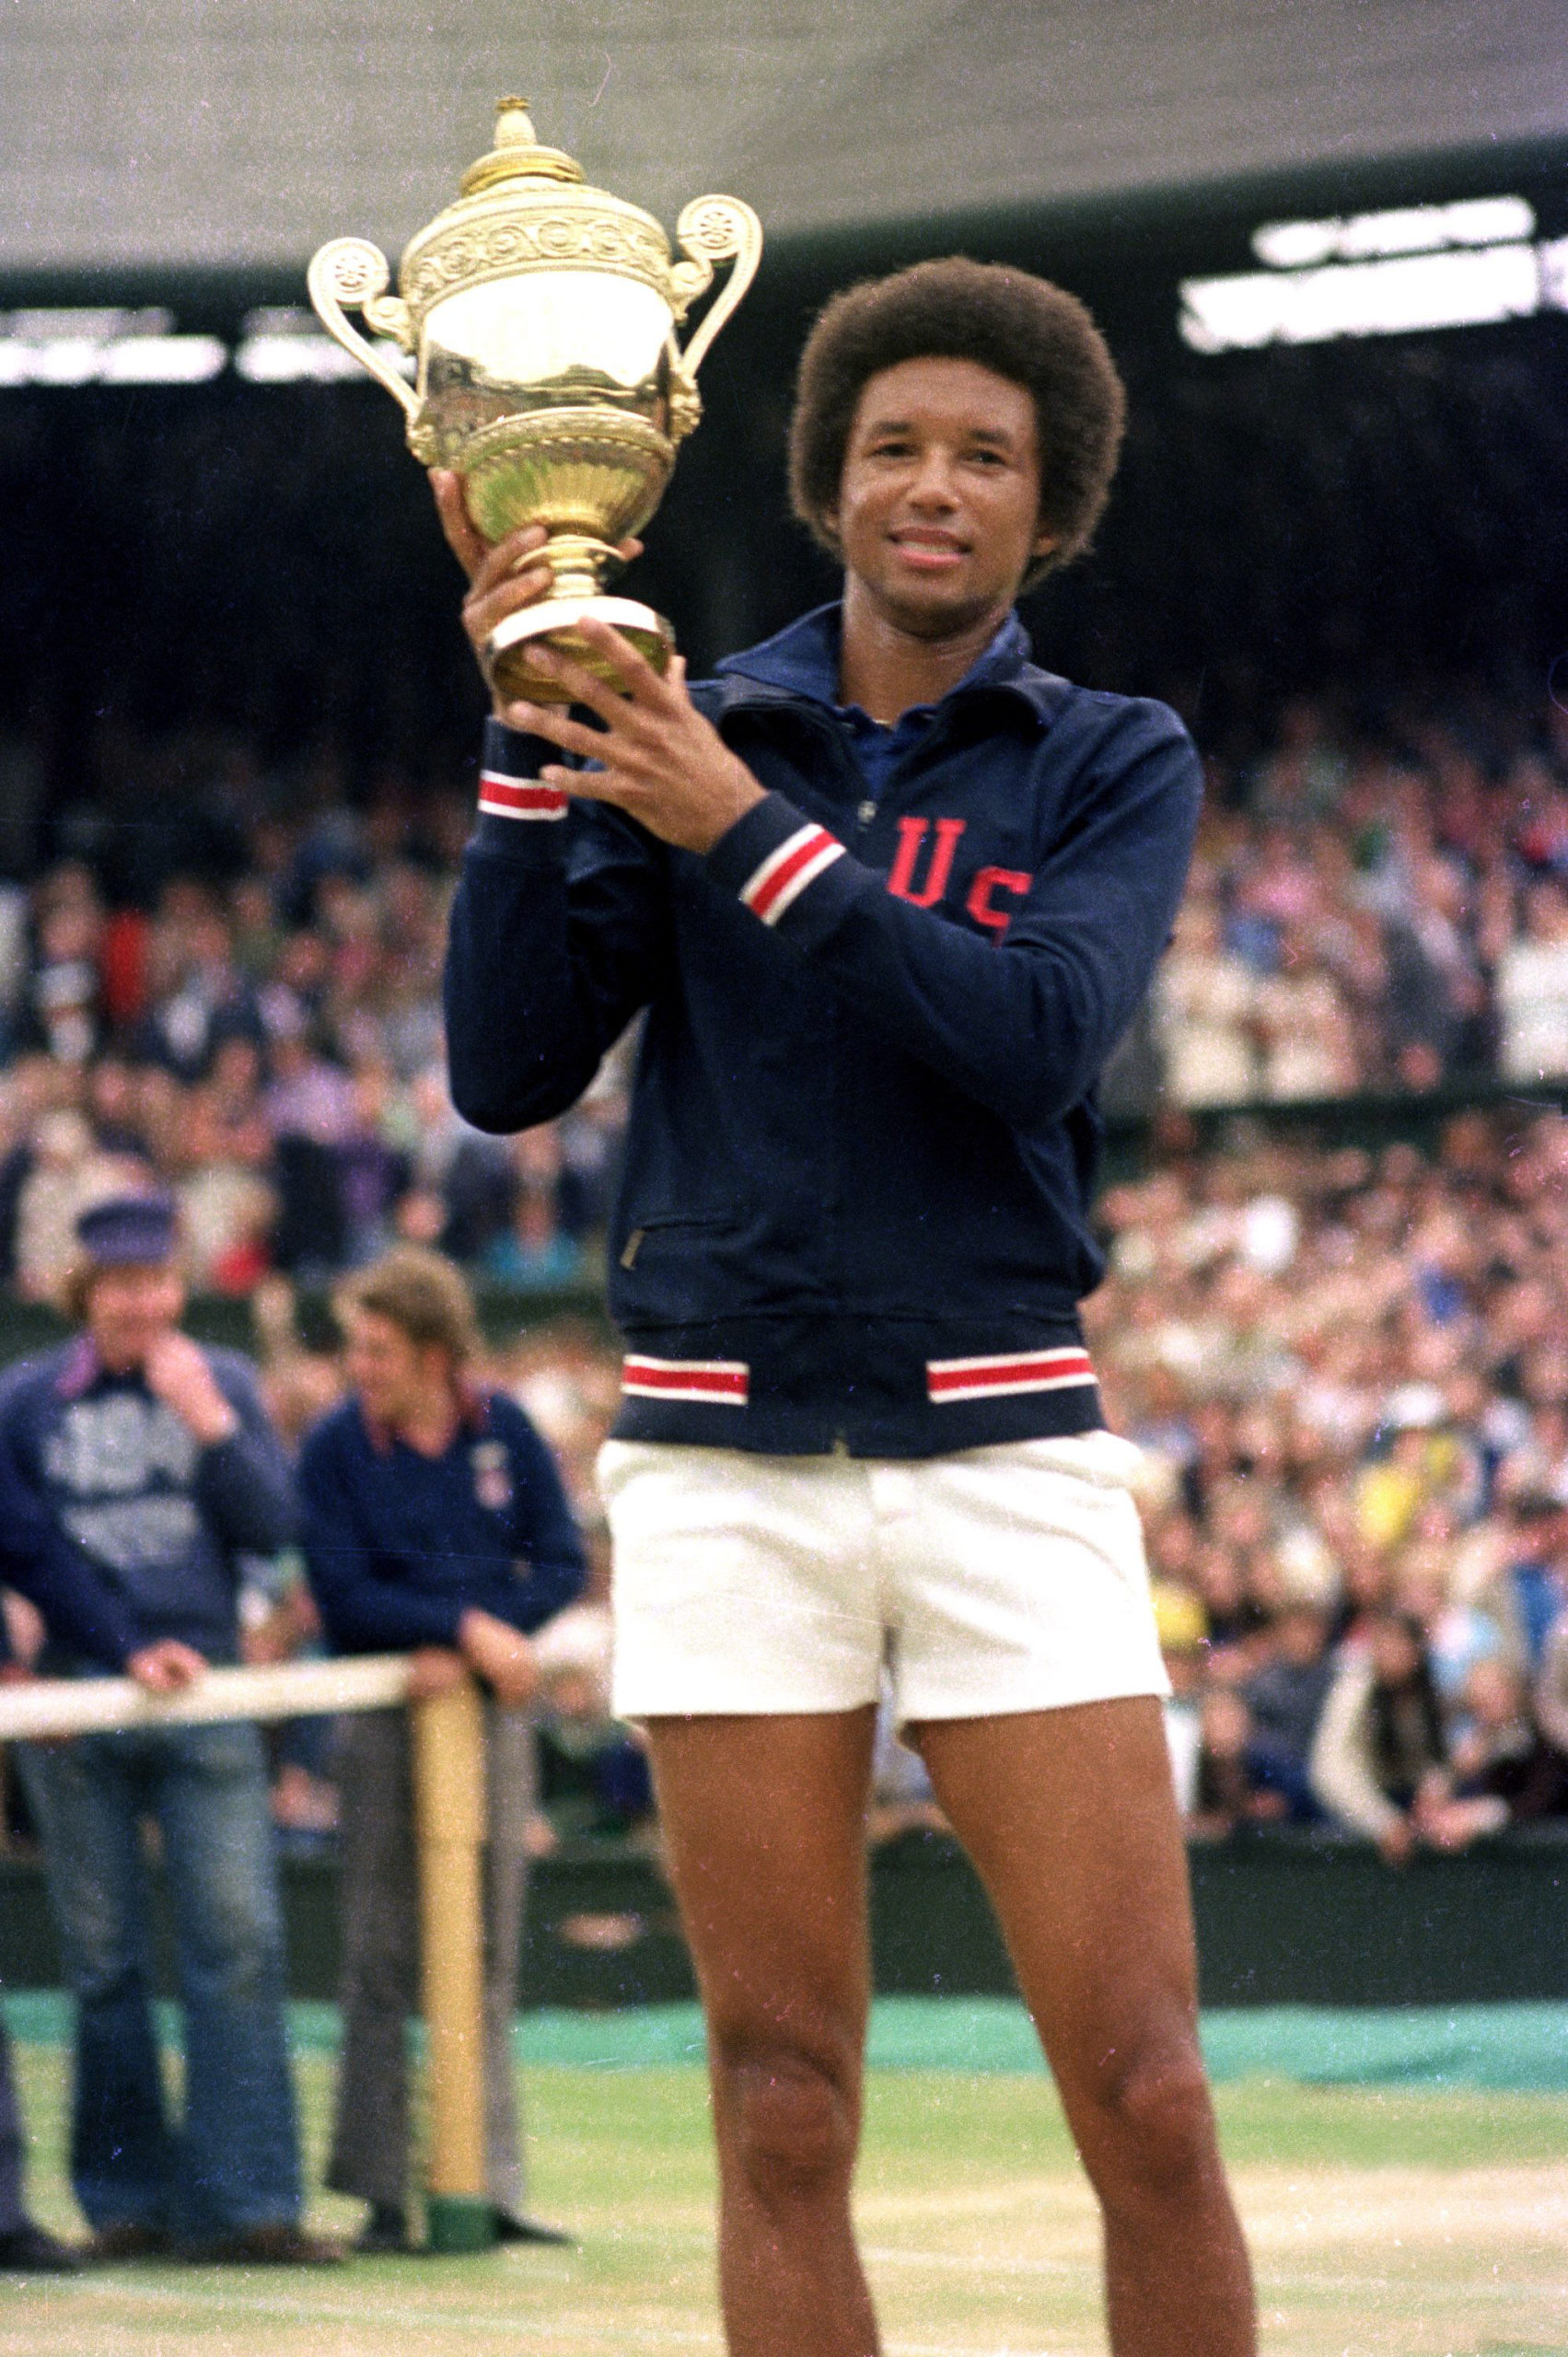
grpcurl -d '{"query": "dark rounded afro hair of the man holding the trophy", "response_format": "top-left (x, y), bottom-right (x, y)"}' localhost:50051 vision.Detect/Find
top-left (790, 254), bottom-right (1127, 586)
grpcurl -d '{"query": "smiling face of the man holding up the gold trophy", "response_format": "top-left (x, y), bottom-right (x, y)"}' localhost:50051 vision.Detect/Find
top-left (828, 358), bottom-right (1051, 639)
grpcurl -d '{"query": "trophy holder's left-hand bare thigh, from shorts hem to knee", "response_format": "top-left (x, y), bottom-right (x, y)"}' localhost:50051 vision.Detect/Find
top-left (648, 1709), bottom-right (875, 2079)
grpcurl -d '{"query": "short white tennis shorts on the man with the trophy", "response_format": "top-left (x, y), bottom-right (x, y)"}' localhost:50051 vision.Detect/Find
top-left (598, 1433), bottom-right (1169, 1725)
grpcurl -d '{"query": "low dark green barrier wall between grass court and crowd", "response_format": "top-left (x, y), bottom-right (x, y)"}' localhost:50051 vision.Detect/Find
top-left (0, 1831), bottom-right (1568, 2011)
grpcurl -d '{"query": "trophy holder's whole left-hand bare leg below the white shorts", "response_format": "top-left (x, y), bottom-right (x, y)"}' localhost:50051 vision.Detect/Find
top-left (648, 1712), bottom-right (877, 2357)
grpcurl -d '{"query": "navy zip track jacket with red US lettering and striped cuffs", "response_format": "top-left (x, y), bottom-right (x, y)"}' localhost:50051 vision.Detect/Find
top-left (446, 608), bottom-right (1200, 1457)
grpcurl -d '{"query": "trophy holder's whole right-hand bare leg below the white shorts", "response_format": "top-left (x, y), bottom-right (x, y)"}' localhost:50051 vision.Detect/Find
top-left (910, 1697), bottom-right (1257, 2357)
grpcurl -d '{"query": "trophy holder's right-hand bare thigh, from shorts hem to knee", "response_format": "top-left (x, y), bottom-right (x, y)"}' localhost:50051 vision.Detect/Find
top-left (911, 1697), bottom-right (1198, 2131)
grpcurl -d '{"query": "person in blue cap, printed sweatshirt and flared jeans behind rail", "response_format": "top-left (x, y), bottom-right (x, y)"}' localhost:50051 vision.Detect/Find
top-left (0, 1192), bottom-right (337, 2263)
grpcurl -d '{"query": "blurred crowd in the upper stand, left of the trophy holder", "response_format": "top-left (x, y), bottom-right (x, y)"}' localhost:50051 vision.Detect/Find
top-left (0, 759), bottom-right (622, 1301)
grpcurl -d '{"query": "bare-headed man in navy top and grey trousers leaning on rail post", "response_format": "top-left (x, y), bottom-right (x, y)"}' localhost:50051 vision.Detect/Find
top-left (299, 1247), bottom-right (583, 2251)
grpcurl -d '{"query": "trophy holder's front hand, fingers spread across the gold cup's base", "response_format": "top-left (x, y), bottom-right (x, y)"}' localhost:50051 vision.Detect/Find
top-left (502, 620), bottom-right (761, 851)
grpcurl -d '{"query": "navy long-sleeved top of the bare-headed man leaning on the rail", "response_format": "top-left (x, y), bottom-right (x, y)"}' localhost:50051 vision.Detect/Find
top-left (299, 1390), bottom-right (585, 1653)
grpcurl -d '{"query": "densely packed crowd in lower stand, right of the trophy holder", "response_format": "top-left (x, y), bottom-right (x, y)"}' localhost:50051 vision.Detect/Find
top-left (1087, 1106), bottom-right (1568, 1860)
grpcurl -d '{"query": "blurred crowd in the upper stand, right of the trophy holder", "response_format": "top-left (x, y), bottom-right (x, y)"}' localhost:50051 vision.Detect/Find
top-left (1153, 700), bottom-right (1568, 1108)
